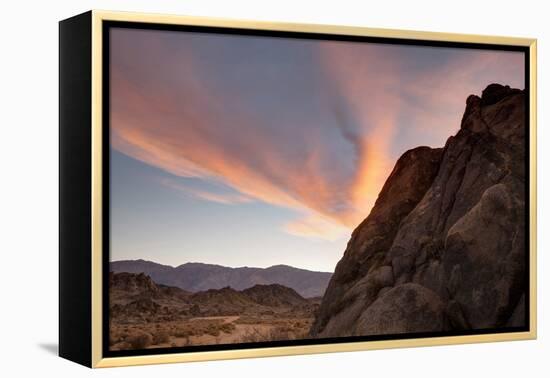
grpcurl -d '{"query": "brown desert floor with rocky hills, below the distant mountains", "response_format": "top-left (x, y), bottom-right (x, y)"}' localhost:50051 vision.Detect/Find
top-left (109, 273), bottom-right (321, 350)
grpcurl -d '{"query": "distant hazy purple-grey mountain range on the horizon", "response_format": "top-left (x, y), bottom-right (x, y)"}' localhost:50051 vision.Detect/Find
top-left (110, 260), bottom-right (332, 298)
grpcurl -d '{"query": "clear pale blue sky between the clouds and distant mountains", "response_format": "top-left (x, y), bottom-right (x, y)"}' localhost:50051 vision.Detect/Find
top-left (111, 151), bottom-right (346, 271)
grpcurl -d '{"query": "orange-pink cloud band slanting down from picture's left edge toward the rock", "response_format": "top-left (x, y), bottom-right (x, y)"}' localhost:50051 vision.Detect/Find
top-left (111, 36), bottom-right (360, 237)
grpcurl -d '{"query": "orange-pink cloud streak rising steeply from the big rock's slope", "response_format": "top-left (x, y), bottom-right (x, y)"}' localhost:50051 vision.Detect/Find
top-left (321, 43), bottom-right (401, 227)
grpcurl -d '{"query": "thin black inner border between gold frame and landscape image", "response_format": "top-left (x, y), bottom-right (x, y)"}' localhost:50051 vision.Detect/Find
top-left (101, 21), bottom-right (531, 357)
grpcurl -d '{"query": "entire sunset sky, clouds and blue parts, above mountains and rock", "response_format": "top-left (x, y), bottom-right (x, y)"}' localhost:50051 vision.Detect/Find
top-left (109, 28), bottom-right (524, 271)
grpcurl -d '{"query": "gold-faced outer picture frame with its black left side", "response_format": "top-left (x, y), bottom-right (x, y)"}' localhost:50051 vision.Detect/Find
top-left (60, 10), bottom-right (537, 368)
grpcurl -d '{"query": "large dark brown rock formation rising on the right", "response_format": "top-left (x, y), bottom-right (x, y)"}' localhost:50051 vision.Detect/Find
top-left (311, 84), bottom-right (526, 337)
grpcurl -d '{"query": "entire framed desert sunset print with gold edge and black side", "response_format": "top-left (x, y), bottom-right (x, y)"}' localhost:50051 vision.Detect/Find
top-left (59, 11), bottom-right (536, 367)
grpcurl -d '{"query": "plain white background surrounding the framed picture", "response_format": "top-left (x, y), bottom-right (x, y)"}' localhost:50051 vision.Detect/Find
top-left (0, 0), bottom-right (550, 378)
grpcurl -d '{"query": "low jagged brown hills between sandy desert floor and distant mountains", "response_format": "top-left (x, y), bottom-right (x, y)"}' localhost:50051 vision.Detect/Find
top-left (109, 272), bottom-right (319, 322)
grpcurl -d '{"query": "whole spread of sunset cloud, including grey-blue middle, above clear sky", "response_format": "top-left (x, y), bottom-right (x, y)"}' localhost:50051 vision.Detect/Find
top-left (111, 29), bottom-right (523, 240)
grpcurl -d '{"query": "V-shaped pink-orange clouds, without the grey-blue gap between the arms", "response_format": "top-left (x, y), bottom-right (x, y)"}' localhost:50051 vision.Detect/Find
top-left (111, 31), bottom-right (522, 240)
